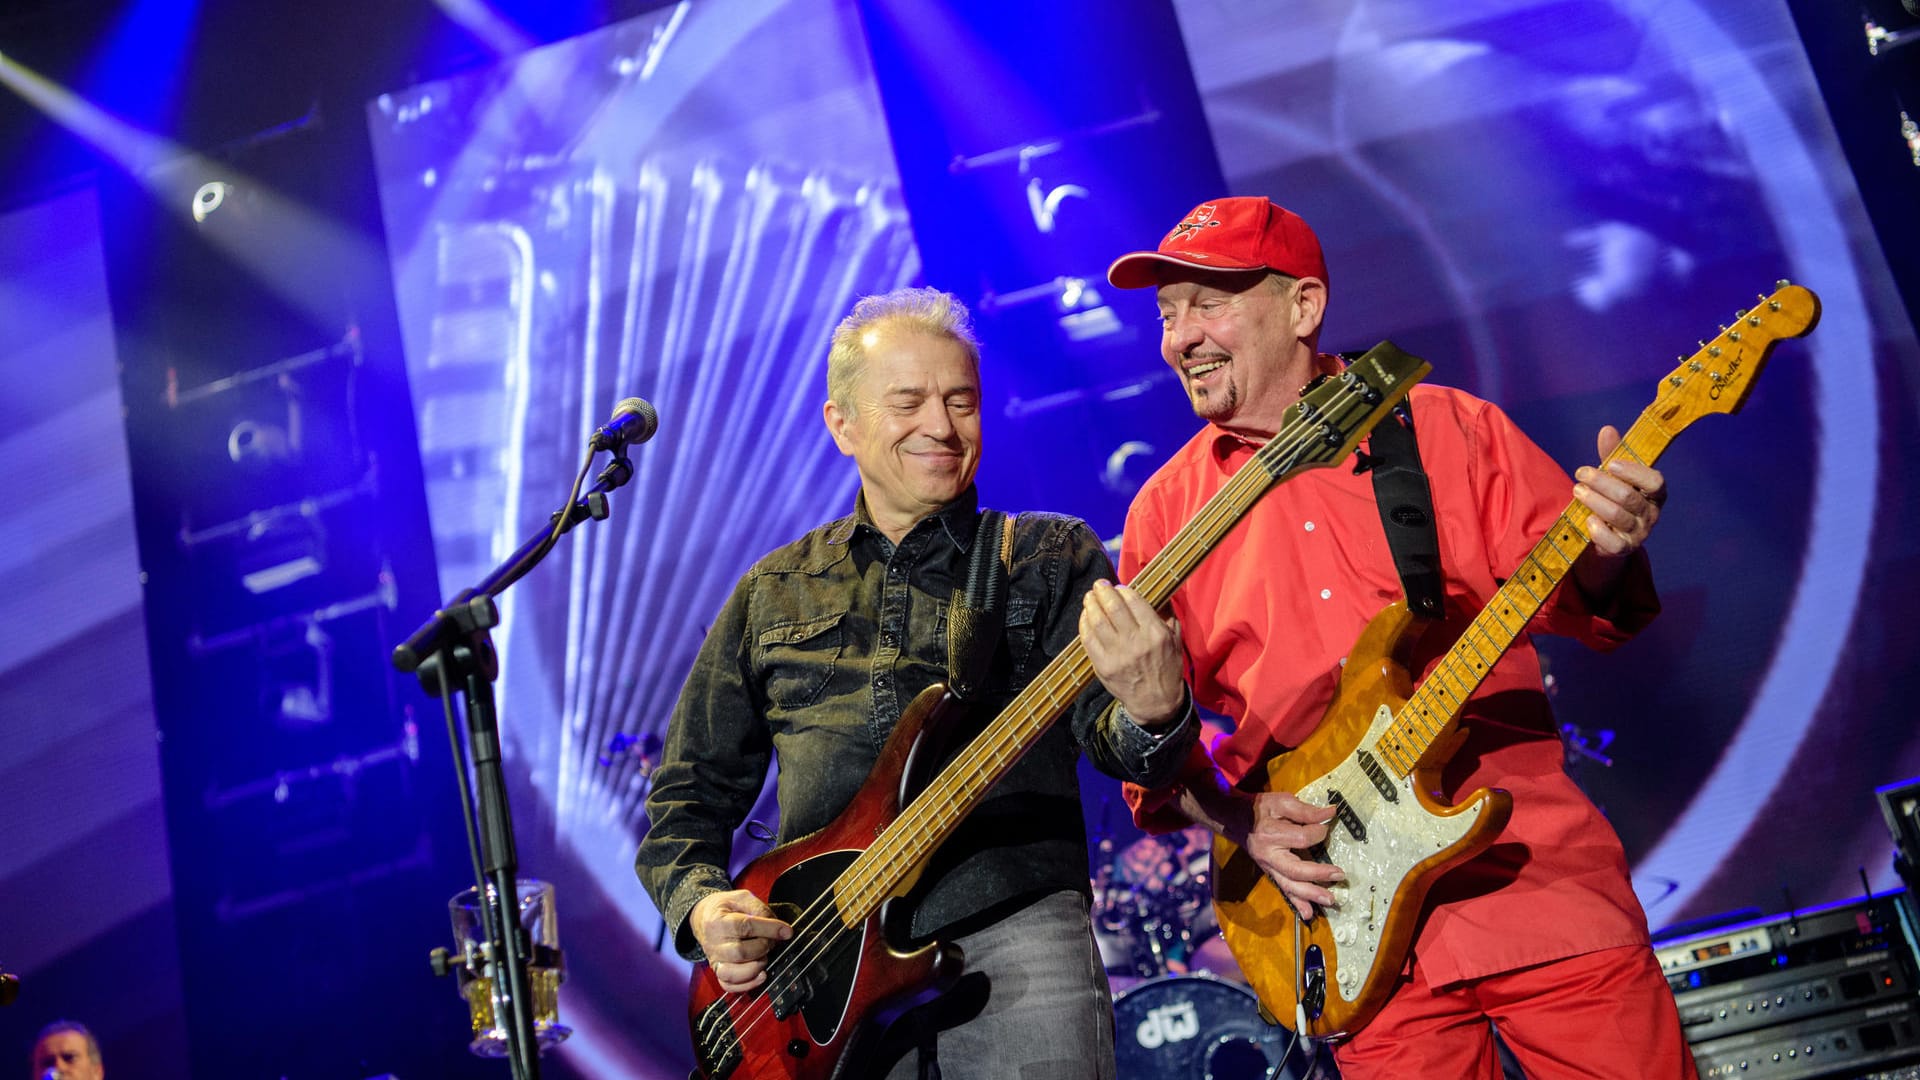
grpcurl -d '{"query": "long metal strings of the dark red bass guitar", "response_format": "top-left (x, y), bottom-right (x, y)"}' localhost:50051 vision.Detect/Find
top-left (701, 377), bottom-right (1411, 1061)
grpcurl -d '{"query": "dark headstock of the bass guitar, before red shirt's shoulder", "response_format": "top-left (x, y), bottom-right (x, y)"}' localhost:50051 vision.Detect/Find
top-left (1254, 342), bottom-right (1432, 479)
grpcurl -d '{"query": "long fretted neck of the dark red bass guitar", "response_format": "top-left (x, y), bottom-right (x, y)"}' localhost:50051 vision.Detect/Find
top-left (833, 367), bottom-right (1427, 924)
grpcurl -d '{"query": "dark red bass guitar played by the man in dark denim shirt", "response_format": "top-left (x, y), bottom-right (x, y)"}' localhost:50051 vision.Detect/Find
top-left (687, 344), bottom-right (1428, 1080)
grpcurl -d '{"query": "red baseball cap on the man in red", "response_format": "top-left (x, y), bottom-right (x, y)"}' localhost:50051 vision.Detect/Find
top-left (1106, 196), bottom-right (1327, 288)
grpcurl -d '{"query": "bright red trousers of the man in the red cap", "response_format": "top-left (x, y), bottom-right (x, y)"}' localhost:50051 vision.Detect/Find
top-left (1334, 945), bottom-right (1697, 1080)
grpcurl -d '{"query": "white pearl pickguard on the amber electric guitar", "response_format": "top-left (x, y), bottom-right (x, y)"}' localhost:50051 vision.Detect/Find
top-left (1296, 705), bottom-right (1482, 1001)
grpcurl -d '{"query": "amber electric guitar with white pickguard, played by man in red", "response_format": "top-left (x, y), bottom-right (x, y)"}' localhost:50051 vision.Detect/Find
top-left (1213, 281), bottom-right (1820, 1038)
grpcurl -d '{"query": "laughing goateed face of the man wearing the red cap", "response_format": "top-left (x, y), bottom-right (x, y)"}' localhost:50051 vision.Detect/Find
top-left (1158, 271), bottom-right (1327, 436)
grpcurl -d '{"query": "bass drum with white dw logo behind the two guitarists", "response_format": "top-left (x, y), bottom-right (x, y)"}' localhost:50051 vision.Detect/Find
top-left (1114, 976), bottom-right (1332, 1080)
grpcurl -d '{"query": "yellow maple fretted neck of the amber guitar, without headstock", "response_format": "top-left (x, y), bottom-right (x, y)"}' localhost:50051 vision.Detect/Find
top-left (1379, 405), bottom-right (1678, 776)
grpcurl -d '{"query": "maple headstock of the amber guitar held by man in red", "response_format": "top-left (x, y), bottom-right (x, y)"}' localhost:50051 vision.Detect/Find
top-left (1651, 281), bottom-right (1820, 432)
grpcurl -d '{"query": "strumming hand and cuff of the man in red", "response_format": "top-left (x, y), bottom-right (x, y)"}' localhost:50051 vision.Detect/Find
top-left (1179, 773), bottom-right (1346, 920)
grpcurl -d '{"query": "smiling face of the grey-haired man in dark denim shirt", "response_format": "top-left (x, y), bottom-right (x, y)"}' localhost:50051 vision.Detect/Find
top-left (824, 323), bottom-right (979, 542)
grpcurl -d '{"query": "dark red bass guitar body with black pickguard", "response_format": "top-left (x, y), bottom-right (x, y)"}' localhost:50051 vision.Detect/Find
top-left (687, 686), bottom-right (964, 1080)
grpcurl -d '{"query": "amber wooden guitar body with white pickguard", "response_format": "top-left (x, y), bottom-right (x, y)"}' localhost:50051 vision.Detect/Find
top-left (1213, 603), bottom-right (1513, 1038)
